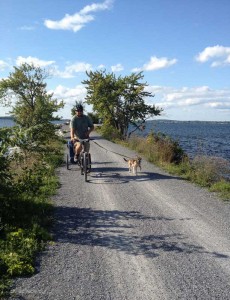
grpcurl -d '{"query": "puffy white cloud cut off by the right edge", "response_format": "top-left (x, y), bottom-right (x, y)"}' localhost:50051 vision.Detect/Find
top-left (195, 45), bottom-right (230, 67)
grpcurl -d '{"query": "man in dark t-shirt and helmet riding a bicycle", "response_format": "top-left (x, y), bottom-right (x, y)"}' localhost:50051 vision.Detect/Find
top-left (68, 104), bottom-right (94, 163)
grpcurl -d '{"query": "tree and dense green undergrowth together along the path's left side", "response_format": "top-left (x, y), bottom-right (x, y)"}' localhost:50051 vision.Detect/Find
top-left (0, 64), bottom-right (63, 298)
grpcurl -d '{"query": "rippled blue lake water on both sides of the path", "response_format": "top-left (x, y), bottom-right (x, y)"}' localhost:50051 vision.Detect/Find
top-left (0, 117), bottom-right (230, 161)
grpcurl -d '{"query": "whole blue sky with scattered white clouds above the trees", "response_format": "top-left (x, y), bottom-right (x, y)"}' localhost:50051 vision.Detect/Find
top-left (0, 0), bottom-right (230, 121)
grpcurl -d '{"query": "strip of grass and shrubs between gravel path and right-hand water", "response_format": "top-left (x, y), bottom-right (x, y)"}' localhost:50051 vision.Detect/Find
top-left (97, 128), bottom-right (230, 201)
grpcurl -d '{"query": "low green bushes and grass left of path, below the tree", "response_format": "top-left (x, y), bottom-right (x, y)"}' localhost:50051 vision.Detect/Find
top-left (0, 139), bottom-right (64, 298)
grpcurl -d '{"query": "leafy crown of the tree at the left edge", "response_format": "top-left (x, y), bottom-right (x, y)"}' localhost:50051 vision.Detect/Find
top-left (0, 63), bottom-right (64, 128)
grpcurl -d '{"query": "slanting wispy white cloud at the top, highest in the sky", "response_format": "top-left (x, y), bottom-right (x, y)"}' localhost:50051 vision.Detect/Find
top-left (44, 0), bottom-right (113, 32)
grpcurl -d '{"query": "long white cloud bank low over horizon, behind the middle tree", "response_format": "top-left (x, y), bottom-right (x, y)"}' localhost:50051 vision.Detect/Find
top-left (50, 84), bottom-right (230, 120)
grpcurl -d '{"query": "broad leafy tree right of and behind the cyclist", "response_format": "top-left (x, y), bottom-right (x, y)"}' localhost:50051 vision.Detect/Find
top-left (82, 71), bottom-right (162, 139)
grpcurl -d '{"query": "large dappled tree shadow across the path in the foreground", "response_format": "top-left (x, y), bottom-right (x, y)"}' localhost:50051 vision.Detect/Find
top-left (54, 206), bottom-right (229, 258)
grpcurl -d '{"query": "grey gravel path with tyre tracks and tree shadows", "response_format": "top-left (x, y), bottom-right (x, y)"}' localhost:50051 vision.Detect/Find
top-left (10, 132), bottom-right (230, 300)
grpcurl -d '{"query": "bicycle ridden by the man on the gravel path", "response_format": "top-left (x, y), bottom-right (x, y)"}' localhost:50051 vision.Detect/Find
top-left (66, 139), bottom-right (91, 182)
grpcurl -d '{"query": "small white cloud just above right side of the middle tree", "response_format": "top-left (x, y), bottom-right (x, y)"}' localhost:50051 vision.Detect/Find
top-left (132, 56), bottom-right (177, 72)
